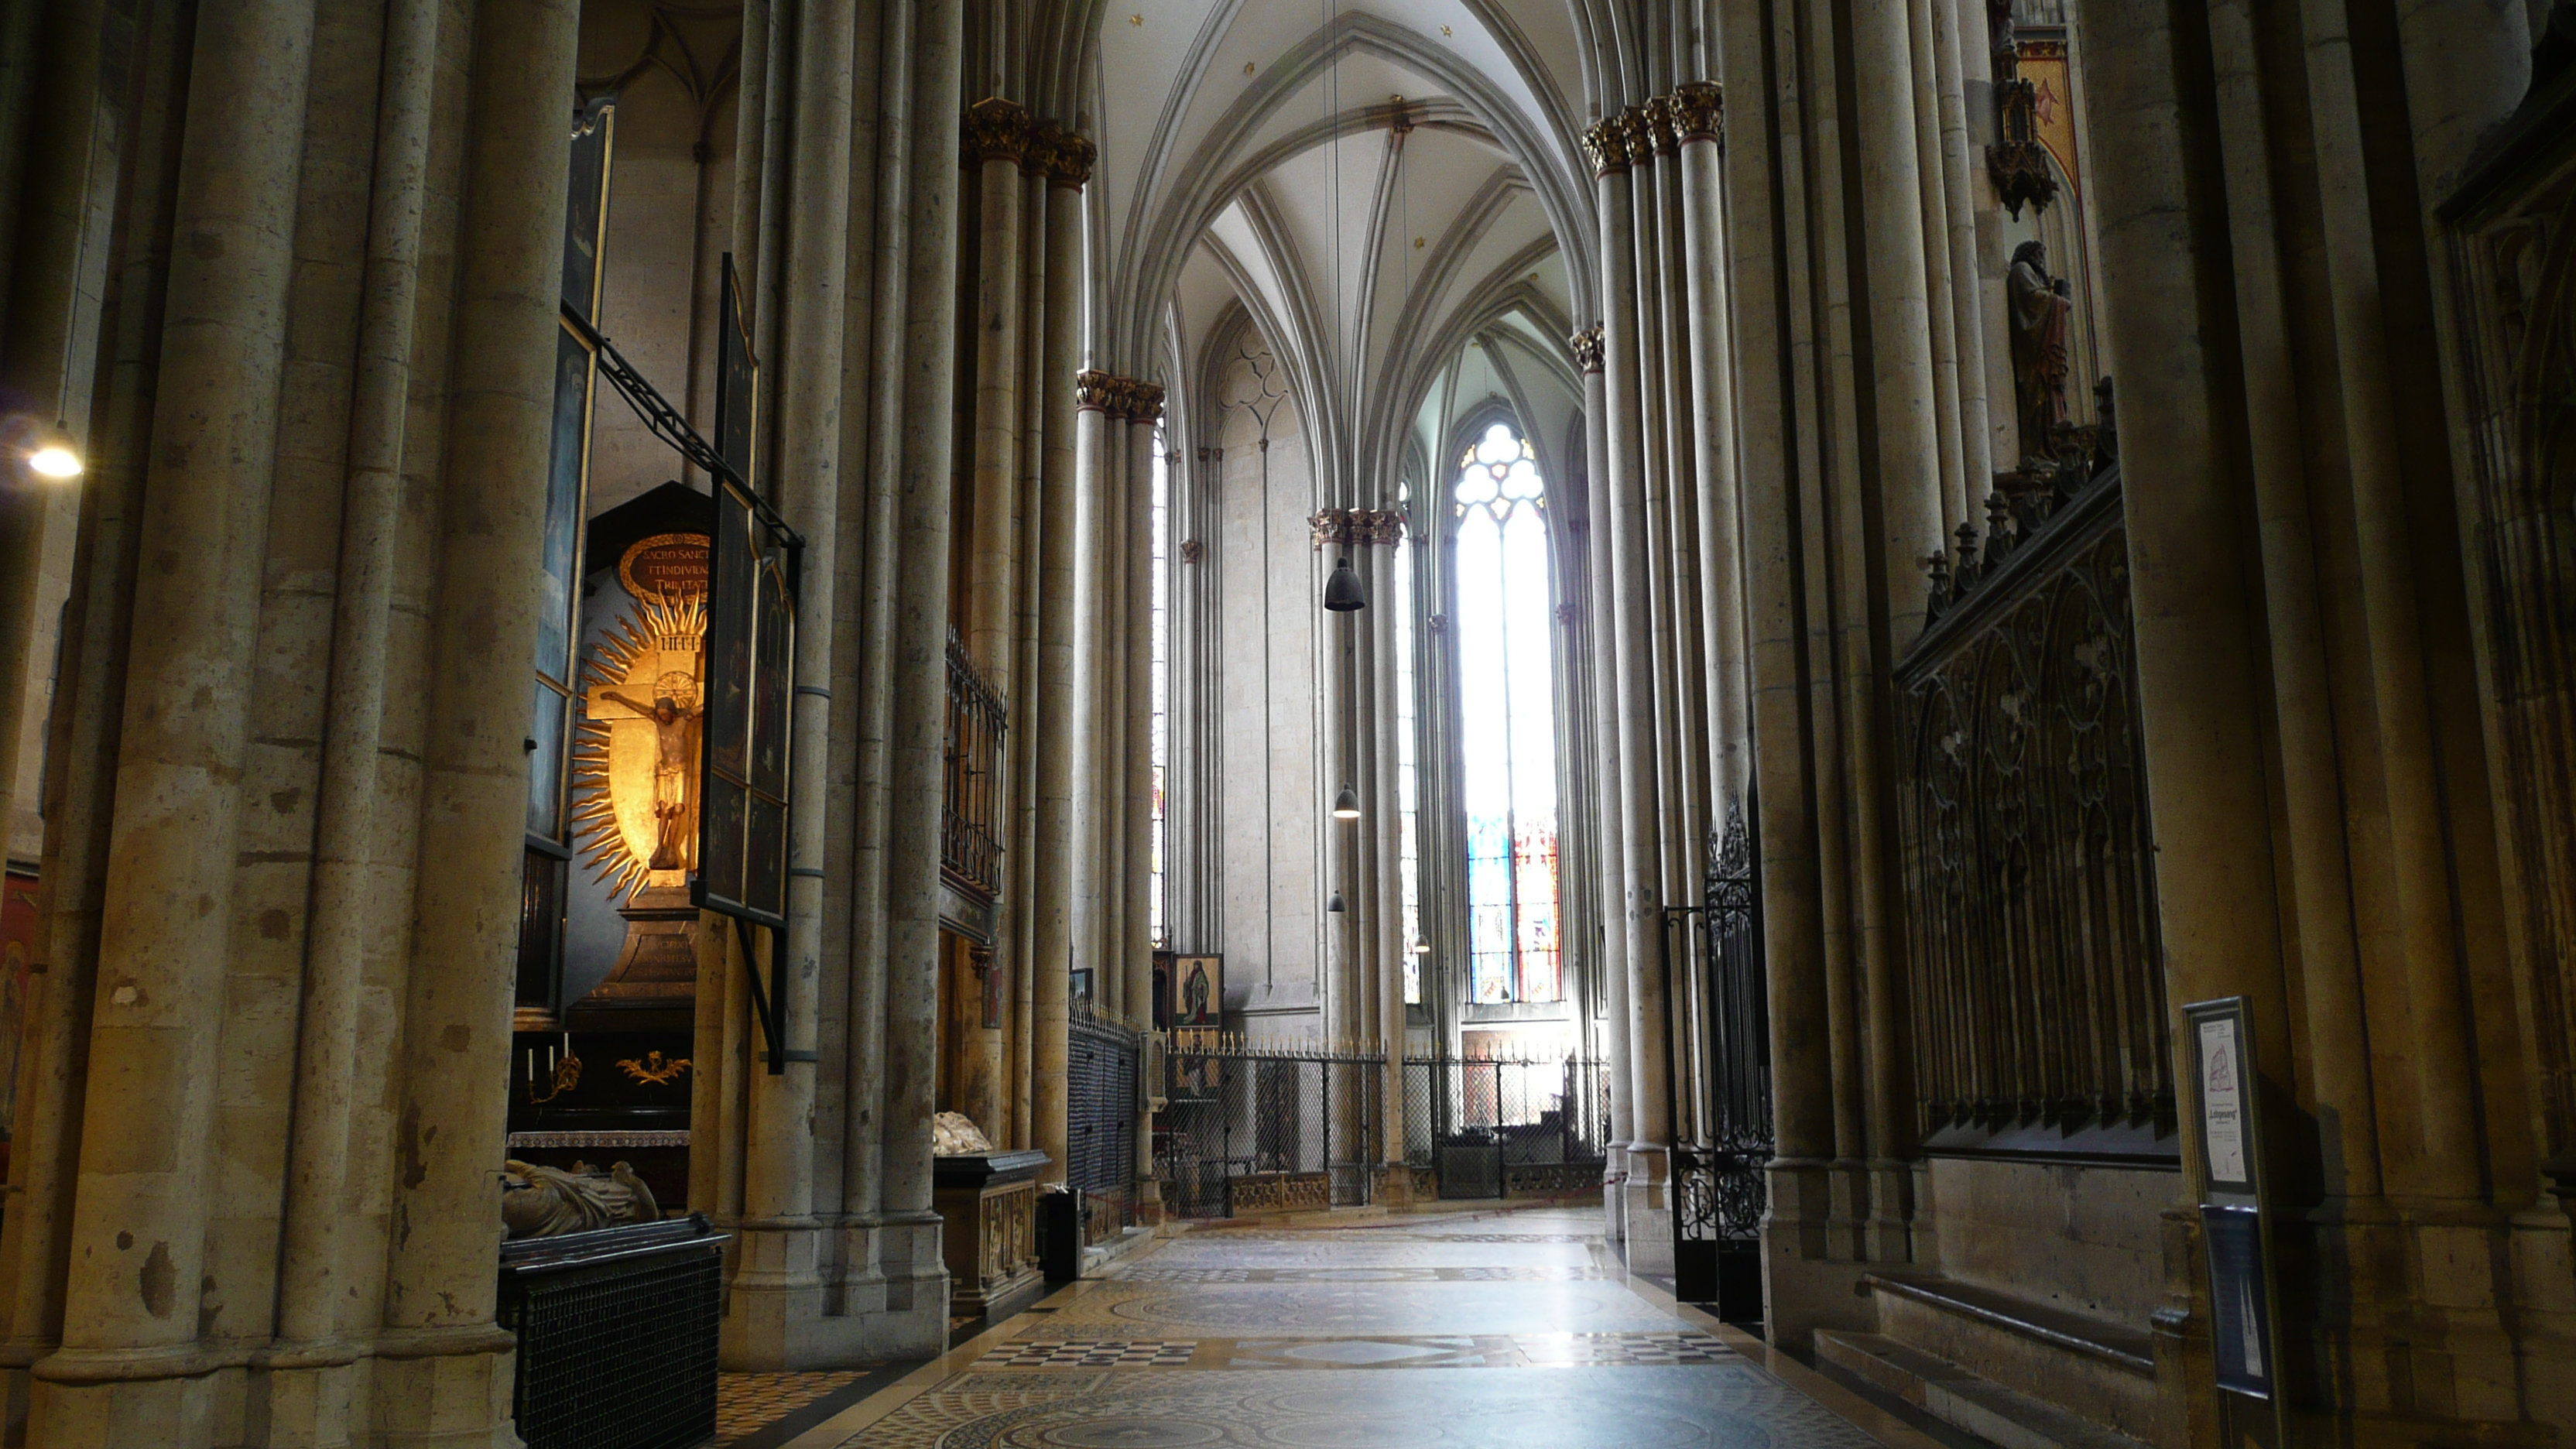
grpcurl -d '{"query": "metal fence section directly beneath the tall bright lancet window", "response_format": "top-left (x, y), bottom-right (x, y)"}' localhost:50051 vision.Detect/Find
top-left (1404, 1054), bottom-right (1610, 1199)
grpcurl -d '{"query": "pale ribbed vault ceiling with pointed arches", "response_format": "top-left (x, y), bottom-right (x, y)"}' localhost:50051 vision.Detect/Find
top-left (1084, 0), bottom-right (1592, 503)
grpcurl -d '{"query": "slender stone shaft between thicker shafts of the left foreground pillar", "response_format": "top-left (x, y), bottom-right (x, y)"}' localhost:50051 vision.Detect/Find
top-left (274, 0), bottom-right (438, 1346)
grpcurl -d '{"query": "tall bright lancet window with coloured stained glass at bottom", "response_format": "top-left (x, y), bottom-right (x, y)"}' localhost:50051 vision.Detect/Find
top-left (1453, 423), bottom-right (1564, 1000)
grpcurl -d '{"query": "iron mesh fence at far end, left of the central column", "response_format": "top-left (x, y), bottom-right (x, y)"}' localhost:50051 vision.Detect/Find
top-left (1154, 1029), bottom-right (1386, 1217)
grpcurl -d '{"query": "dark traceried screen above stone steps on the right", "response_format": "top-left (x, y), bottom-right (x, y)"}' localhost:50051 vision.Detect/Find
top-left (1896, 461), bottom-right (2174, 1158)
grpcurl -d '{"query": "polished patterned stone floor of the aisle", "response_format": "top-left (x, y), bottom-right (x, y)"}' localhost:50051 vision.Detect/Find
top-left (793, 1209), bottom-right (1922, 1449)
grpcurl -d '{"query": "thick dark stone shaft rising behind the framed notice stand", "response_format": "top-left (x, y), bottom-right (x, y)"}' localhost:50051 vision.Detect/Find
top-left (2084, 5), bottom-right (2290, 1139)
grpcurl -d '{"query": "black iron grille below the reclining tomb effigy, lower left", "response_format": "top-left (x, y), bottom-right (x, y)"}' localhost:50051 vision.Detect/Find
top-left (500, 1214), bottom-right (726, 1449)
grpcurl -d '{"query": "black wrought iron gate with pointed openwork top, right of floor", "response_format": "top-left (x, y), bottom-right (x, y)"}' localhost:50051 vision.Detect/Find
top-left (1664, 804), bottom-right (1773, 1323)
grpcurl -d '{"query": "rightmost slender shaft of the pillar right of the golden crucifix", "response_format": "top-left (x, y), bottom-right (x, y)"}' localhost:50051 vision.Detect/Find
top-left (881, 0), bottom-right (966, 1323)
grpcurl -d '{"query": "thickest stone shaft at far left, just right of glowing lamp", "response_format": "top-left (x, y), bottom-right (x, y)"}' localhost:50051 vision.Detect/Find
top-left (34, 0), bottom-right (317, 1413)
